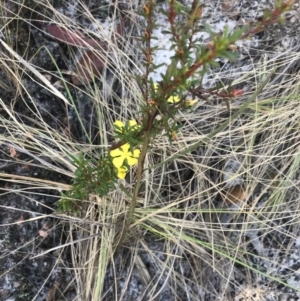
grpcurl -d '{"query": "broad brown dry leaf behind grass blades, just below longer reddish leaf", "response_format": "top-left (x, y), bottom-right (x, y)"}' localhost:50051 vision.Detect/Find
top-left (71, 47), bottom-right (107, 86)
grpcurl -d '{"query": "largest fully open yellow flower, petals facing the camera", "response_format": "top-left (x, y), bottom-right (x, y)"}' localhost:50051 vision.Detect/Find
top-left (110, 143), bottom-right (141, 168)
